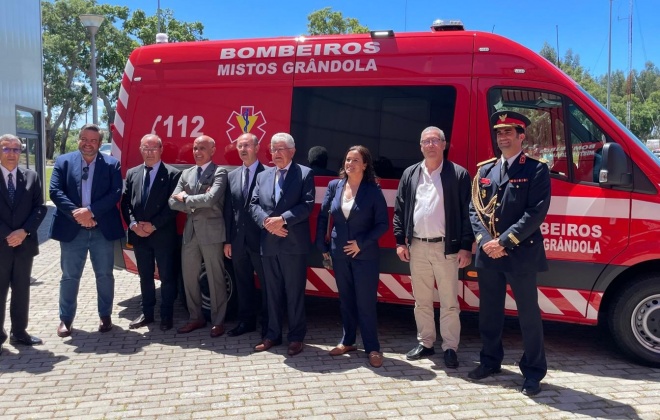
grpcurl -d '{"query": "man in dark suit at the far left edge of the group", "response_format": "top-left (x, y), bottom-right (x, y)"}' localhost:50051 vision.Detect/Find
top-left (0, 134), bottom-right (46, 352)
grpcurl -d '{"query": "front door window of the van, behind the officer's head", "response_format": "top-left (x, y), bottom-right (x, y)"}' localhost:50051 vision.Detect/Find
top-left (488, 88), bottom-right (577, 179)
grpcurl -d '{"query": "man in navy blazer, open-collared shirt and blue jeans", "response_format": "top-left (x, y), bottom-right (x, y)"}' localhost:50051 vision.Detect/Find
top-left (50, 124), bottom-right (124, 337)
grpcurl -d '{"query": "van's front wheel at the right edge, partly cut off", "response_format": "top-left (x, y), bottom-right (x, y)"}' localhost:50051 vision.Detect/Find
top-left (608, 273), bottom-right (660, 368)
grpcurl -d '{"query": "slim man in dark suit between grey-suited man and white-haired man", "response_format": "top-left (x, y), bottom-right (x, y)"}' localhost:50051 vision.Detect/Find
top-left (224, 133), bottom-right (268, 337)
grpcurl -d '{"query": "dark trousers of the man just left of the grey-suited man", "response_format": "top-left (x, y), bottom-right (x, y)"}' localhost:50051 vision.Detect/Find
top-left (133, 244), bottom-right (178, 319)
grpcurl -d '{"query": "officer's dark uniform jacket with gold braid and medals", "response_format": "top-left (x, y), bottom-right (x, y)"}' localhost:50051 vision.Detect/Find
top-left (470, 153), bottom-right (550, 272)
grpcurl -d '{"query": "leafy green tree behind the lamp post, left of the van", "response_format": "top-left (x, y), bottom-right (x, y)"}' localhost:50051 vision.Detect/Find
top-left (42, 0), bottom-right (203, 159)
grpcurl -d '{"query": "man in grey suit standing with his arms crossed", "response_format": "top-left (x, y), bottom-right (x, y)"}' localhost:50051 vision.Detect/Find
top-left (169, 136), bottom-right (227, 337)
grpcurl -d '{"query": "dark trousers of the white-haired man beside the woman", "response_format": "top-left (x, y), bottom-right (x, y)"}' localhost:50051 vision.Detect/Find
top-left (261, 254), bottom-right (307, 342)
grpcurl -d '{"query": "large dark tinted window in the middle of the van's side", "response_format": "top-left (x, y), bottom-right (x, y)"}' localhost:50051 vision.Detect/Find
top-left (291, 86), bottom-right (456, 179)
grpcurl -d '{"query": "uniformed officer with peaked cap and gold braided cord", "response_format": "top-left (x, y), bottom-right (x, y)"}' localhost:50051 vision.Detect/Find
top-left (468, 111), bottom-right (550, 396)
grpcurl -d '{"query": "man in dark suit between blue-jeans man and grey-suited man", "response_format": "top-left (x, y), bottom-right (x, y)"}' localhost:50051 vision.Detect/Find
top-left (121, 134), bottom-right (181, 331)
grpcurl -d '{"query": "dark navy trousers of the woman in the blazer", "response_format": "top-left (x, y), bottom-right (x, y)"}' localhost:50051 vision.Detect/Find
top-left (332, 258), bottom-right (380, 353)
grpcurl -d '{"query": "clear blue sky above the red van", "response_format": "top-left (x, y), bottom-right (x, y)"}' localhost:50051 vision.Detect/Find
top-left (112, 0), bottom-right (660, 75)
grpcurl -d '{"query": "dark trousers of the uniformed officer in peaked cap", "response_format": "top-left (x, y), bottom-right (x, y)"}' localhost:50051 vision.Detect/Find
top-left (477, 268), bottom-right (548, 381)
